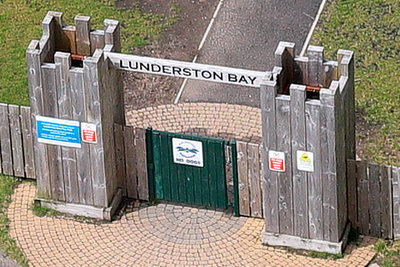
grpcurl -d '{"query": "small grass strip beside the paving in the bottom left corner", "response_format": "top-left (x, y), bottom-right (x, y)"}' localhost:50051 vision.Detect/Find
top-left (0, 174), bottom-right (28, 266)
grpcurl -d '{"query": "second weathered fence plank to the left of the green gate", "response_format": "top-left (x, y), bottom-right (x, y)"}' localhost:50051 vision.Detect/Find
top-left (124, 126), bottom-right (138, 199)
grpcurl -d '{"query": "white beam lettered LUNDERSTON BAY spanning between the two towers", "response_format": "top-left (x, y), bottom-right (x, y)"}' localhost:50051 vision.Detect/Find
top-left (105, 52), bottom-right (271, 87)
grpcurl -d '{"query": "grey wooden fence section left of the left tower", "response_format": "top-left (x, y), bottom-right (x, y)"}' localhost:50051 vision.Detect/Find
top-left (0, 103), bottom-right (36, 179)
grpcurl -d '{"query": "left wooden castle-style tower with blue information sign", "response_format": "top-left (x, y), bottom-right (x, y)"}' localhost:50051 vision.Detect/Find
top-left (26, 11), bottom-right (125, 220)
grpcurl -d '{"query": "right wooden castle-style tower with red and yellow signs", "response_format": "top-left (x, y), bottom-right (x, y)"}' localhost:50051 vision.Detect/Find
top-left (260, 42), bottom-right (355, 253)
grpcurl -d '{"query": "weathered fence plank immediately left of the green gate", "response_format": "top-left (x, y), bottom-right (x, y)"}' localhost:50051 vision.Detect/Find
top-left (135, 128), bottom-right (149, 200)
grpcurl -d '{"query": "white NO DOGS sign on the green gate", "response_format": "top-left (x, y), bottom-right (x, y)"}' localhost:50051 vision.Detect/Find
top-left (172, 138), bottom-right (203, 167)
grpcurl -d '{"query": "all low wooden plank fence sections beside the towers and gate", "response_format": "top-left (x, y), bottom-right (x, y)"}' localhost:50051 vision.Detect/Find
top-left (0, 103), bottom-right (400, 238)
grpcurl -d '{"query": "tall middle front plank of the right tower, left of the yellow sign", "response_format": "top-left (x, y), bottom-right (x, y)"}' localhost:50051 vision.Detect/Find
top-left (290, 84), bottom-right (308, 238)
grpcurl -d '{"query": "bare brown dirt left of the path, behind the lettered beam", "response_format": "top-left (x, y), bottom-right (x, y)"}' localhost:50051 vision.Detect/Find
top-left (116, 0), bottom-right (218, 110)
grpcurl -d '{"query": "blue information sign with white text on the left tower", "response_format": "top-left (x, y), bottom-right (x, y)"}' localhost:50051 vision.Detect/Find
top-left (36, 116), bottom-right (81, 148)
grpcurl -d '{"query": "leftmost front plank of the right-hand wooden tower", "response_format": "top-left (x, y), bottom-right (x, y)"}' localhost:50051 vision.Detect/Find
top-left (260, 81), bottom-right (279, 233)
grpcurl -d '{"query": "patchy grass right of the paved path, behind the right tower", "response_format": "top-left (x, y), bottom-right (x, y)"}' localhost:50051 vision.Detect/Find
top-left (311, 0), bottom-right (400, 165)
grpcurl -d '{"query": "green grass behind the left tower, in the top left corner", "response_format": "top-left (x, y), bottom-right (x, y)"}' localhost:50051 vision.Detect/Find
top-left (0, 0), bottom-right (176, 105)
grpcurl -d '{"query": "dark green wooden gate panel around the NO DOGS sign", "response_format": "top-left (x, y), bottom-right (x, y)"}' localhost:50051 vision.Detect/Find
top-left (151, 131), bottom-right (228, 209)
